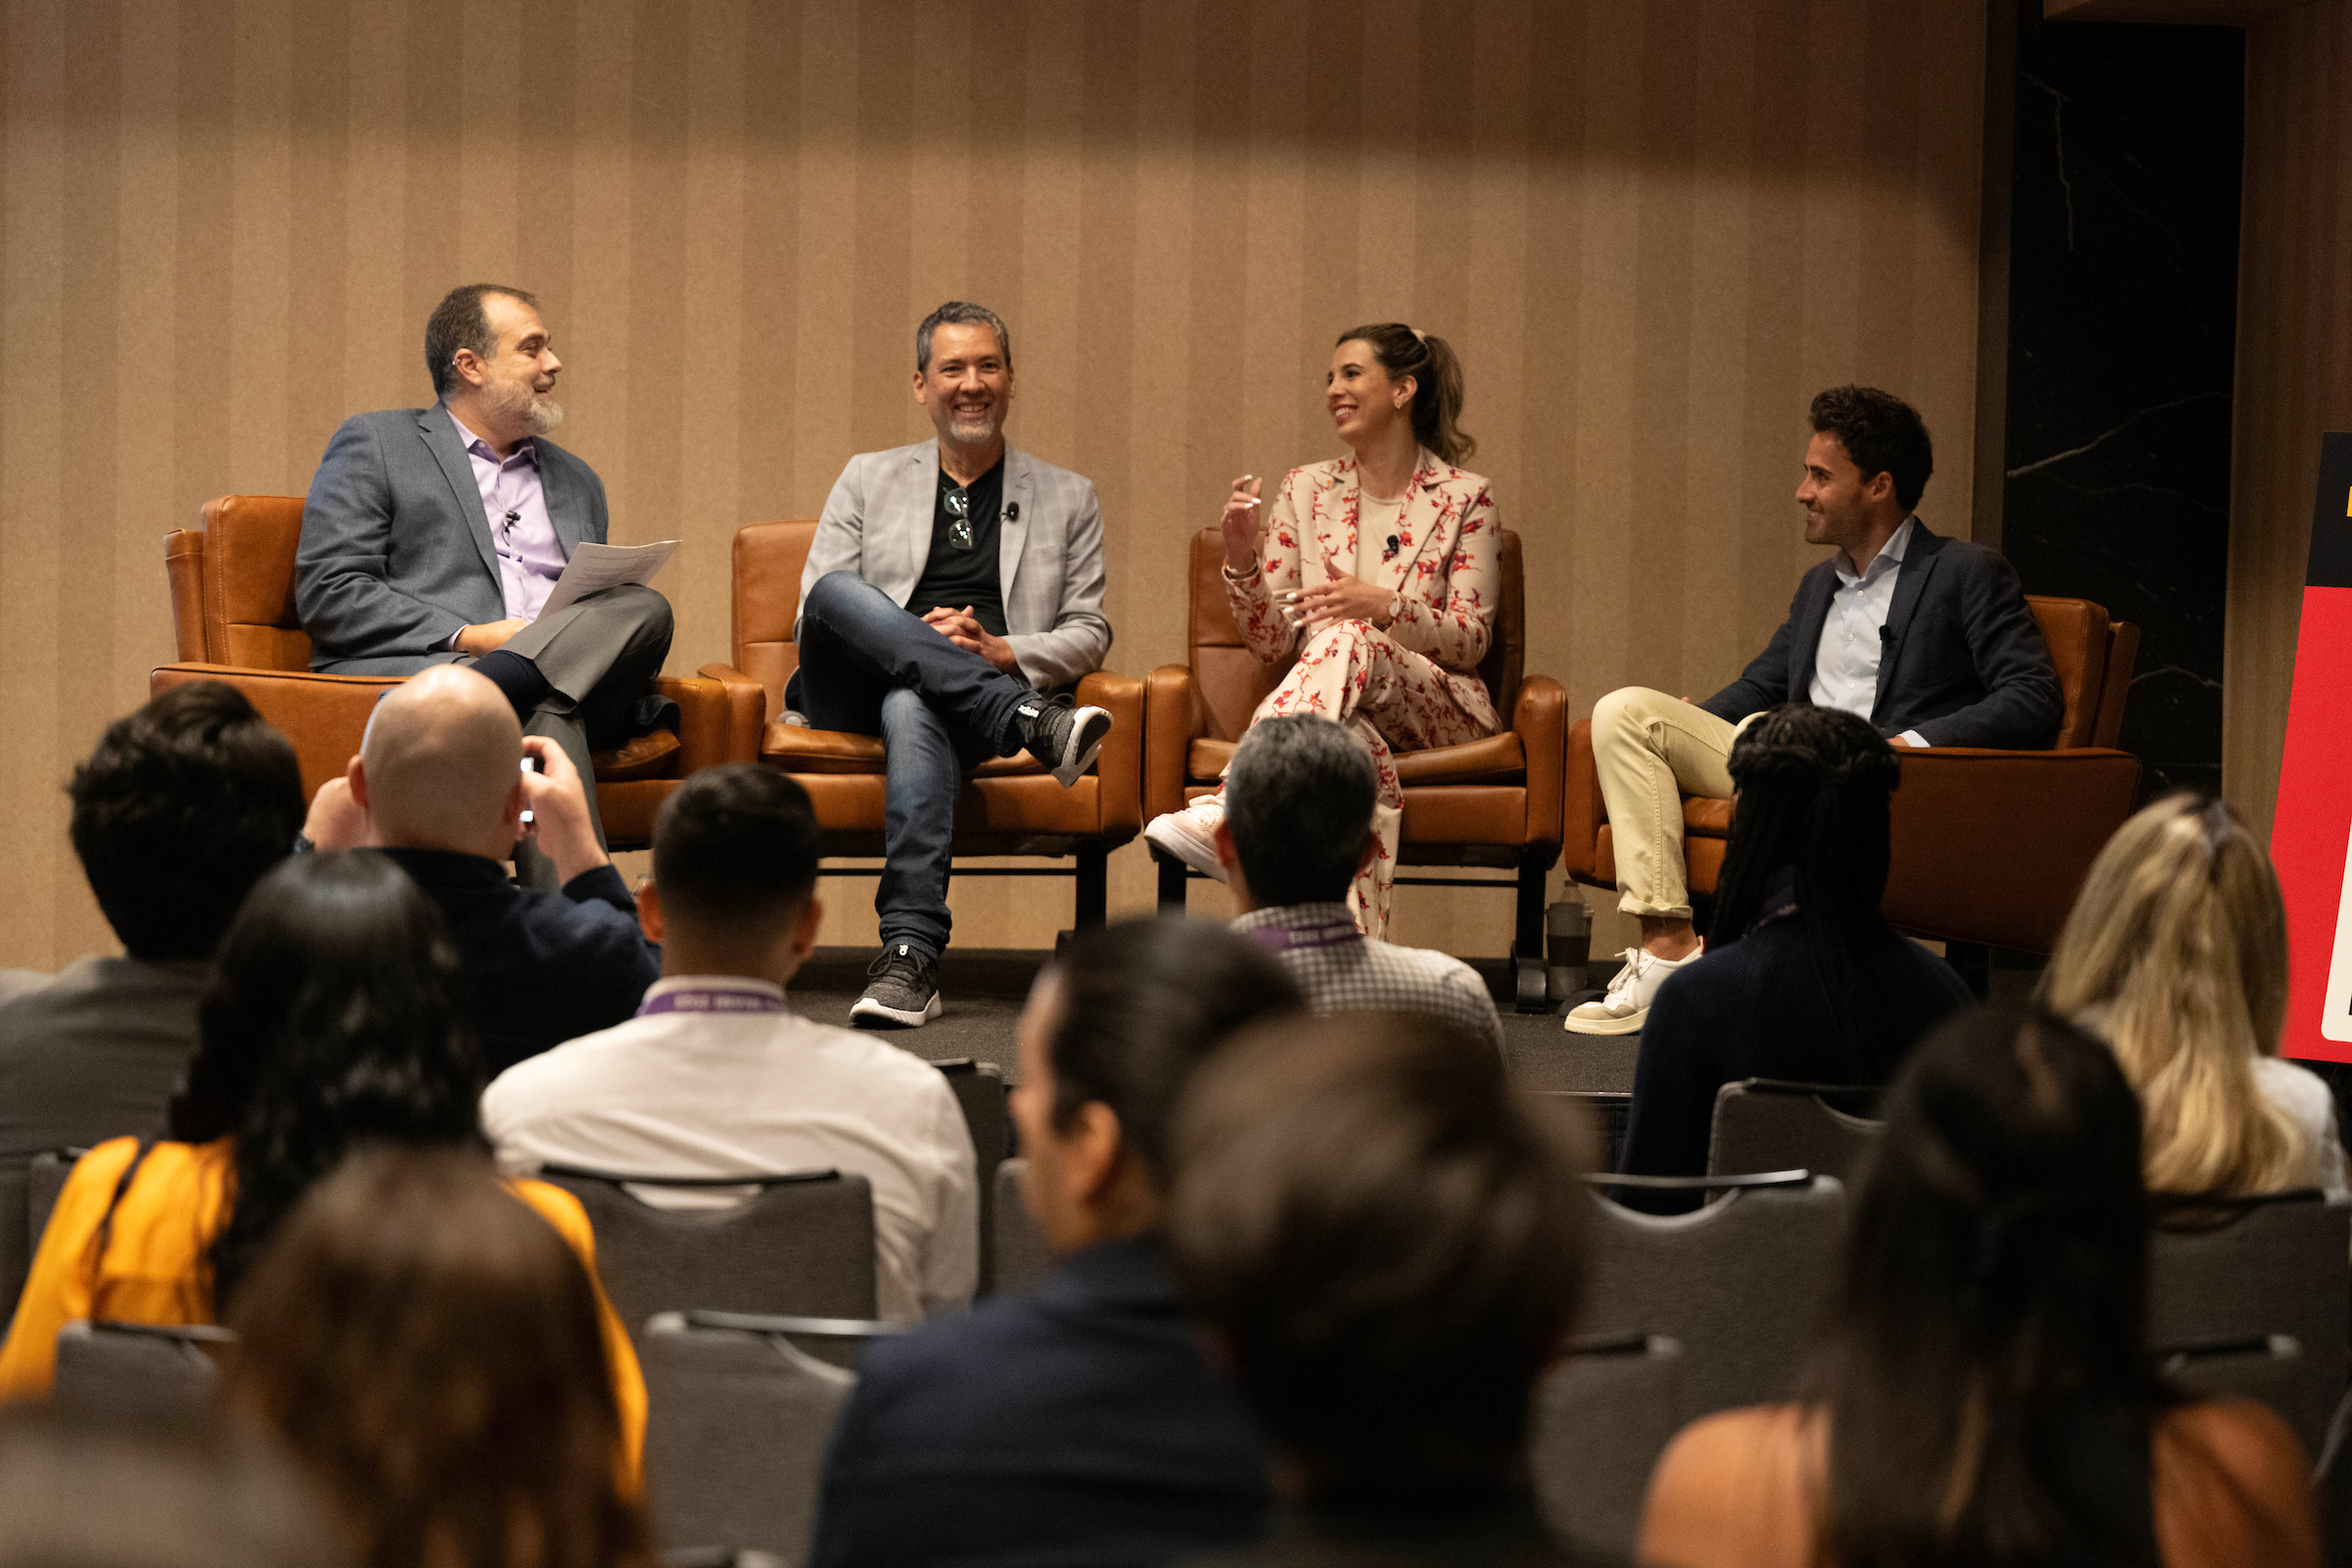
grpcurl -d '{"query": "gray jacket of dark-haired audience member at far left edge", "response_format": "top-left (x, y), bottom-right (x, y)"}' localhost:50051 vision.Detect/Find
top-left (0, 956), bottom-right (212, 1163)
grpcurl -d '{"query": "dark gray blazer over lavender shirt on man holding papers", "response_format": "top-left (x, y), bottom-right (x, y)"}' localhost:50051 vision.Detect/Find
top-left (294, 405), bottom-right (610, 674)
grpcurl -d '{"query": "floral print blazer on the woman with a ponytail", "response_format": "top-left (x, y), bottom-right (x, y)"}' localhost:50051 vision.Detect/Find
top-left (1225, 447), bottom-right (1503, 729)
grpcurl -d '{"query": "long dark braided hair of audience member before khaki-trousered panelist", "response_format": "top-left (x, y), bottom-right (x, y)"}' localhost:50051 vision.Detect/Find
top-left (1707, 703), bottom-right (1900, 1084)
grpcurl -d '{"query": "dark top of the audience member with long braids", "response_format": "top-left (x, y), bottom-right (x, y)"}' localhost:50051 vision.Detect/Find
top-left (1618, 893), bottom-right (1976, 1213)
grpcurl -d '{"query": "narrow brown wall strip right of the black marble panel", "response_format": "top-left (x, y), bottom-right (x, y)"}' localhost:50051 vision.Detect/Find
top-left (2223, 0), bottom-right (2352, 837)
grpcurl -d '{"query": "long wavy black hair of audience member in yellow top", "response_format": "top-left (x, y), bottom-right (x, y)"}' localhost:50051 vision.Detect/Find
top-left (170, 849), bottom-right (487, 1312)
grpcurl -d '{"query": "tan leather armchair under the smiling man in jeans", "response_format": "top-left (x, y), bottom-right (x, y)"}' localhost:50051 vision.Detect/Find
top-left (704, 519), bottom-right (1143, 931)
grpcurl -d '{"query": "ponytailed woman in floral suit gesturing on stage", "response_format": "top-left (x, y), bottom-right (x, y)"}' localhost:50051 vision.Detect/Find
top-left (1143, 322), bottom-right (1503, 938)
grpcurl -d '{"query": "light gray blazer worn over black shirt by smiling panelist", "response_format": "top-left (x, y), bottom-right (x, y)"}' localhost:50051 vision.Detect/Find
top-left (793, 440), bottom-right (1110, 691)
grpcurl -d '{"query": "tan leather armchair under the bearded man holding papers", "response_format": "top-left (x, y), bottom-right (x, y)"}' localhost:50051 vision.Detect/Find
top-left (148, 496), bottom-right (727, 849)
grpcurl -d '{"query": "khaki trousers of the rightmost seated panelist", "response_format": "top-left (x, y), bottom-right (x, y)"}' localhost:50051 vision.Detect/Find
top-left (1592, 686), bottom-right (1759, 919)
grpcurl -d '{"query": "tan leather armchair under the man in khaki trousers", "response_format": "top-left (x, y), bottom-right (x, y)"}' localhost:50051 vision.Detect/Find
top-left (1562, 595), bottom-right (2140, 953)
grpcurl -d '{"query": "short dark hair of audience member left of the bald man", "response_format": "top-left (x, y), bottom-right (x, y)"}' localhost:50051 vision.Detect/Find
top-left (66, 682), bottom-right (304, 964)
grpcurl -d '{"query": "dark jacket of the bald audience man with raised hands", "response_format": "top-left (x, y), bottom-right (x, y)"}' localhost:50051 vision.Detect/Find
top-left (383, 849), bottom-right (661, 1084)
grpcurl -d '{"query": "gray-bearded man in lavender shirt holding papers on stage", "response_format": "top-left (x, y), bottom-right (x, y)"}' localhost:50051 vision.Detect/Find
top-left (294, 282), bottom-right (672, 884)
